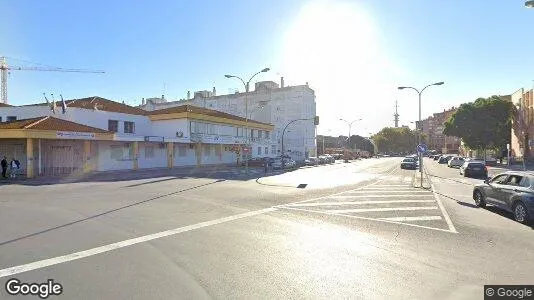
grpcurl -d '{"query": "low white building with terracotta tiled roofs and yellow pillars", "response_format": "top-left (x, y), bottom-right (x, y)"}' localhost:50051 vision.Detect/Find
top-left (0, 97), bottom-right (275, 177)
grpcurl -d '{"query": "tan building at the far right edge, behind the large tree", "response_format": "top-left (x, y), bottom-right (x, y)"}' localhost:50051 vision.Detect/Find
top-left (510, 88), bottom-right (534, 159)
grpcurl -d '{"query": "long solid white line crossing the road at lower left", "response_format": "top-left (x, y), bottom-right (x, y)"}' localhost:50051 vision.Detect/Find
top-left (0, 207), bottom-right (277, 278)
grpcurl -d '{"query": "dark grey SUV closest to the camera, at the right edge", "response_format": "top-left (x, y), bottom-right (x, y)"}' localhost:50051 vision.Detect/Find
top-left (473, 171), bottom-right (534, 224)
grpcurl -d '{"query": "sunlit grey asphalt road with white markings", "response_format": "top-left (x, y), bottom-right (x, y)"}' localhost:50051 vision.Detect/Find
top-left (0, 158), bottom-right (534, 299)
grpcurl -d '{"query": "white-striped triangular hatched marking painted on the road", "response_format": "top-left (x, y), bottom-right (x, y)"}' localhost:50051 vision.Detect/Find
top-left (281, 173), bottom-right (455, 232)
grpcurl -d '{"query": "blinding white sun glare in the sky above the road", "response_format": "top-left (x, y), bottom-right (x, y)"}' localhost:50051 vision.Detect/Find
top-left (282, 0), bottom-right (404, 134)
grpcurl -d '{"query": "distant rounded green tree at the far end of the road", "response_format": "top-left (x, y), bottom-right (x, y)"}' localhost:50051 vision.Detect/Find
top-left (372, 127), bottom-right (418, 153)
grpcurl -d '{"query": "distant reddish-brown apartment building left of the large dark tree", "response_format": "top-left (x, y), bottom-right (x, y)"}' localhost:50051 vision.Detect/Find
top-left (416, 107), bottom-right (461, 153)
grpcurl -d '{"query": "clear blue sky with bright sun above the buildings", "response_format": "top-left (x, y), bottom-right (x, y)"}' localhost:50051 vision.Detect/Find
top-left (0, 0), bottom-right (534, 136)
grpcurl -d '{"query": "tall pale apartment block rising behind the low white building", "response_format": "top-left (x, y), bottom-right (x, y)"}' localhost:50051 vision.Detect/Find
top-left (139, 78), bottom-right (317, 160)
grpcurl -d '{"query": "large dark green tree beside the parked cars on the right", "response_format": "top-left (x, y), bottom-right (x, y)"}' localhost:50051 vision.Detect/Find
top-left (443, 96), bottom-right (514, 156)
